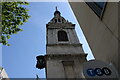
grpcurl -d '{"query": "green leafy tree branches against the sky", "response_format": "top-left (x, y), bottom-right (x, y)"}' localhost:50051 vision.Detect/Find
top-left (1, 2), bottom-right (30, 46)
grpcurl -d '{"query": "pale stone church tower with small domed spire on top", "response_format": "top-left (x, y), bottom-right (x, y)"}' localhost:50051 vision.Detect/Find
top-left (46, 7), bottom-right (87, 78)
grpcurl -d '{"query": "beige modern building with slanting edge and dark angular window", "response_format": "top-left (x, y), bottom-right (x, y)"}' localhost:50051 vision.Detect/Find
top-left (69, 0), bottom-right (120, 75)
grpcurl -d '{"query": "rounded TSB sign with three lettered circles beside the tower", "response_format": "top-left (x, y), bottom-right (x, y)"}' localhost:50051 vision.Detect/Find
top-left (83, 60), bottom-right (118, 78)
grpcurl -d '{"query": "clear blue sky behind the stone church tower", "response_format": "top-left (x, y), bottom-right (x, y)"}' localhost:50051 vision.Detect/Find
top-left (1, 2), bottom-right (93, 78)
